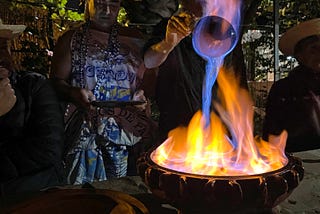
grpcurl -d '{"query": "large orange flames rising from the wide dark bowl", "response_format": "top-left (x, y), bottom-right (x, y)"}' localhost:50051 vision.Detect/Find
top-left (151, 69), bottom-right (288, 176)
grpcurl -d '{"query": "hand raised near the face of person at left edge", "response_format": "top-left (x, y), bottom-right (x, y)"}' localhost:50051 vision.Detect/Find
top-left (0, 78), bottom-right (17, 116)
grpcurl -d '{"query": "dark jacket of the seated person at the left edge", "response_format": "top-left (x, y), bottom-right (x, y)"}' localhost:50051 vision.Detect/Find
top-left (0, 73), bottom-right (64, 195)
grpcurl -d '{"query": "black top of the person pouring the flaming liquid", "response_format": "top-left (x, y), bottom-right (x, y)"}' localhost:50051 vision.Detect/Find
top-left (156, 37), bottom-right (205, 138)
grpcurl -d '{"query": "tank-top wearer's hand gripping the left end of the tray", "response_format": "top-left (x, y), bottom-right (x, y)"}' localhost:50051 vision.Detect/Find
top-left (71, 87), bottom-right (96, 109)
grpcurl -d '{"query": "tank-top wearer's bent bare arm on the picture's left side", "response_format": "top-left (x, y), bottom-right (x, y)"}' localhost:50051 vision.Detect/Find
top-left (50, 31), bottom-right (94, 108)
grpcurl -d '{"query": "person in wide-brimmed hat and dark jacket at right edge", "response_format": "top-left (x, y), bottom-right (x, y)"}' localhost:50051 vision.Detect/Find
top-left (263, 18), bottom-right (320, 152)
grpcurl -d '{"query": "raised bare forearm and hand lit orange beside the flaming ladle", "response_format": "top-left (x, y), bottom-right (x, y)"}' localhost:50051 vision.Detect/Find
top-left (144, 13), bottom-right (195, 68)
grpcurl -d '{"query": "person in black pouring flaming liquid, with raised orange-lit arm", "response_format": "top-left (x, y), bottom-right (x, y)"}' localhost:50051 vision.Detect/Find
top-left (144, 0), bottom-right (206, 142)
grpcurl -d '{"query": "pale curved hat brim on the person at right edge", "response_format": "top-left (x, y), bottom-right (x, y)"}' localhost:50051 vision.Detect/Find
top-left (279, 18), bottom-right (320, 56)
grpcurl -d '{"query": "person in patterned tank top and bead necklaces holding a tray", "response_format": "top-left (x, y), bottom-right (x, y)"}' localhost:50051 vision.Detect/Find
top-left (50, 0), bottom-right (152, 184)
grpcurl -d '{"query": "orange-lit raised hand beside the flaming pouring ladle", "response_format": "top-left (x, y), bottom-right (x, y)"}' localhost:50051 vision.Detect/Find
top-left (165, 12), bottom-right (196, 45)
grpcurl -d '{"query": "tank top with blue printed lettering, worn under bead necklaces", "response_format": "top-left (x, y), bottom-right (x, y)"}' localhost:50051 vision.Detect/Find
top-left (71, 25), bottom-right (142, 101)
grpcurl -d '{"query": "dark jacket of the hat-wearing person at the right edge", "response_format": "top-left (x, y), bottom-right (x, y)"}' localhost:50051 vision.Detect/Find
top-left (263, 66), bottom-right (320, 152)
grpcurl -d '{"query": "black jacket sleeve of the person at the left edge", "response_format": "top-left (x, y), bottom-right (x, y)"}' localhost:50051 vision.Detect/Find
top-left (7, 74), bottom-right (64, 174)
